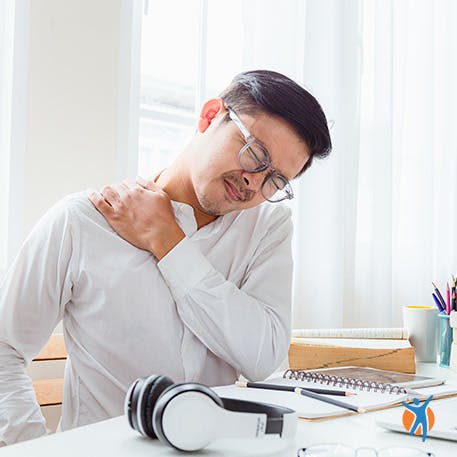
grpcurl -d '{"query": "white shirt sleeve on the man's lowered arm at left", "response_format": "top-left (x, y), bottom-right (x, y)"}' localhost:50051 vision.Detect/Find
top-left (0, 201), bottom-right (74, 444)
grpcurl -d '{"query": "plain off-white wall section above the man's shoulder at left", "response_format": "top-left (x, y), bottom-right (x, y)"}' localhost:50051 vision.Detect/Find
top-left (22, 0), bottom-right (122, 236)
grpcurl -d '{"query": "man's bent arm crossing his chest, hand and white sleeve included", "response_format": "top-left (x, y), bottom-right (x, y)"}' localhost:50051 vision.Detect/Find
top-left (90, 181), bottom-right (292, 380)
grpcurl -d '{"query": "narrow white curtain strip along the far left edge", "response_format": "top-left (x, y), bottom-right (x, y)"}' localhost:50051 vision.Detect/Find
top-left (0, 0), bottom-right (14, 279)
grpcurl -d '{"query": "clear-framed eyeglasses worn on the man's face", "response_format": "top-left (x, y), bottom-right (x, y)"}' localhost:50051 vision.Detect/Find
top-left (227, 107), bottom-right (294, 203)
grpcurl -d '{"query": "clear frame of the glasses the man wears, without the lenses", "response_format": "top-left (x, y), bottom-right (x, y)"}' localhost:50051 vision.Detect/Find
top-left (225, 106), bottom-right (294, 203)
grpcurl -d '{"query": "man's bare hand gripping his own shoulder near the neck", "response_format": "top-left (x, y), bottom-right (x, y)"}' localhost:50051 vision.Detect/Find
top-left (89, 178), bottom-right (185, 260)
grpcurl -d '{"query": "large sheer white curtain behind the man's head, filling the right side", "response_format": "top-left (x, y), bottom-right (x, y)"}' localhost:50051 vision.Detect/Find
top-left (240, 0), bottom-right (457, 327)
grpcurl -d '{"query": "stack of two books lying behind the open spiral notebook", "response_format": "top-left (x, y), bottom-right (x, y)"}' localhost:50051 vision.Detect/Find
top-left (289, 328), bottom-right (416, 373)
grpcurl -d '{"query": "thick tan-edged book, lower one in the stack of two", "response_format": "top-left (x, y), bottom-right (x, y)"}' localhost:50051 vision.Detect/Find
top-left (288, 337), bottom-right (416, 373)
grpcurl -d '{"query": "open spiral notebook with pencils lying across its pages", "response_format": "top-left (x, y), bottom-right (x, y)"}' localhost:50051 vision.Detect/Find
top-left (214, 367), bottom-right (457, 420)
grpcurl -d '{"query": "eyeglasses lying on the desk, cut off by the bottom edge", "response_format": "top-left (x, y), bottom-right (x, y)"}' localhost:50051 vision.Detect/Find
top-left (297, 443), bottom-right (435, 457)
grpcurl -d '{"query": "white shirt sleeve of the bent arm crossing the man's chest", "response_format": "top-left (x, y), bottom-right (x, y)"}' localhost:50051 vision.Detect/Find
top-left (158, 205), bottom-right (293, 380)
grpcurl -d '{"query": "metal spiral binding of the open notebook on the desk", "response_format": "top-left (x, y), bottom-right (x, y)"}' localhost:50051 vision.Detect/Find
top-left (283, 369), bottom-right (407, 395)
